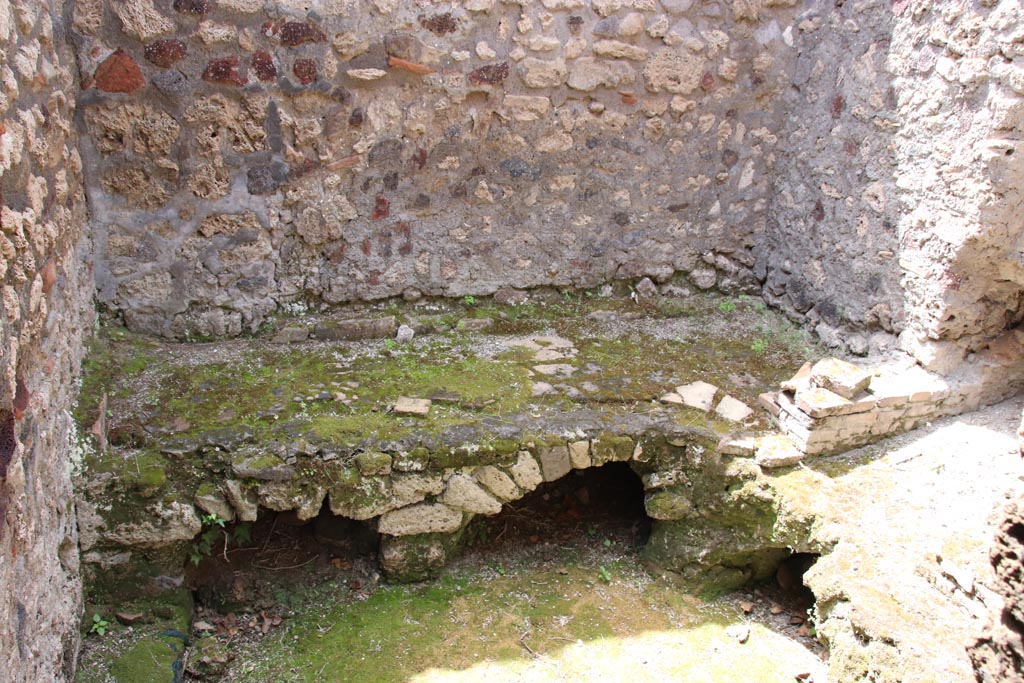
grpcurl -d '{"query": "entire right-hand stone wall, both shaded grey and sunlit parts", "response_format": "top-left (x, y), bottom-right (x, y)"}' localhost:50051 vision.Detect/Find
top-left (759, 0), bottom-right (1024, 373)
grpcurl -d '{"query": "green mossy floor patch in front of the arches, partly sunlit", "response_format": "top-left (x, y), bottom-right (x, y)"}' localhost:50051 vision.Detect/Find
top-left (231, 549), bottom-right (822, 683)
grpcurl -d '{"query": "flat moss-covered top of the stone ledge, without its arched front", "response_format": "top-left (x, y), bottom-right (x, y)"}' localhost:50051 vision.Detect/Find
top-left (76, 294), bottom-right (817, 456)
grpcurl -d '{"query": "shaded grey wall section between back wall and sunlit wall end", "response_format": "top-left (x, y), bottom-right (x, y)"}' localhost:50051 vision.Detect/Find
top-left (758, 1), bottom-right (905, 353)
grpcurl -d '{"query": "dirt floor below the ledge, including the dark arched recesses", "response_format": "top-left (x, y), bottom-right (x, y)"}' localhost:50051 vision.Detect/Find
top-left (169, 465), bottom-right (824, 682)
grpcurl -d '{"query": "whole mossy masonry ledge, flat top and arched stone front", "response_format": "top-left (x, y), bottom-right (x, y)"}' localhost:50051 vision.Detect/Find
top-left (77, 299), bottom-right (815, 587)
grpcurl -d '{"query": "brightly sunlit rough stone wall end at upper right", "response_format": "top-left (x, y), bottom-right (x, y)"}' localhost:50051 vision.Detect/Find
top-left (891, 2), bottom-right (1024, 382)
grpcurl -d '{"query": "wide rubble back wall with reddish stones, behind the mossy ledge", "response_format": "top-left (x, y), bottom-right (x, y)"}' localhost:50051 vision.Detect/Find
top-left (74, 0), bottom-right (799, 338)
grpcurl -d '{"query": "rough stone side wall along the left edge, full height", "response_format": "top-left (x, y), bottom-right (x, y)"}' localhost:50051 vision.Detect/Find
top-left (0, 0), bottom-right (92, 682)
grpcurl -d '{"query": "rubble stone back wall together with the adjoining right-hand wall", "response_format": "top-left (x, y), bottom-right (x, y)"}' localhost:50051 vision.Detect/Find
top-left (72, 0), bottom-right (1024, 389)
